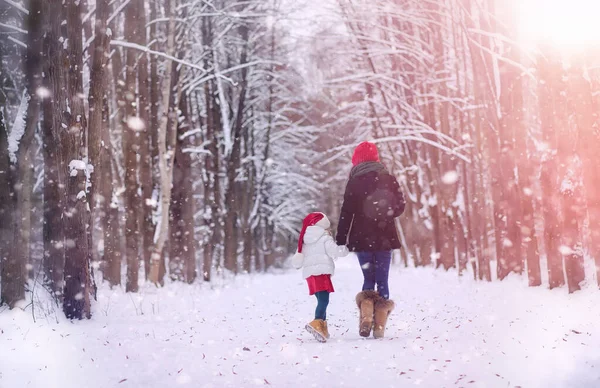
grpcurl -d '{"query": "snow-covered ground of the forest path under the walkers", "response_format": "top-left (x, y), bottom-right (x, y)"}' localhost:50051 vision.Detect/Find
top-left (0, 256), bottom-right (600, 388)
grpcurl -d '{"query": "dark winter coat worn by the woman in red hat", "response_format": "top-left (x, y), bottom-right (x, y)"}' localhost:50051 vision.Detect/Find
top-left (336, 162), bottom-right (406, 252)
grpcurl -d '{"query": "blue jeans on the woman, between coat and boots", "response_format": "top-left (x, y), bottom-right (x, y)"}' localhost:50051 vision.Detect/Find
top-left (356, 251), bottom-right (392, 299)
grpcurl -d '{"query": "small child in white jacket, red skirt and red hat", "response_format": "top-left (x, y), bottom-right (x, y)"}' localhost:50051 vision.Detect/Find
top-left (292, 213), bottom-right (348, 342)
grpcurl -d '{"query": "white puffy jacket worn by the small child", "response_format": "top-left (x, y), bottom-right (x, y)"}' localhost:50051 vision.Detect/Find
top-left (292, 221), bottom-right (349, 278)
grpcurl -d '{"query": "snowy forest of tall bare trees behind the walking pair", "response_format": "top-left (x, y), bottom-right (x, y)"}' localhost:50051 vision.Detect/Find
top-left (0, 0), bottom-right (600, 318)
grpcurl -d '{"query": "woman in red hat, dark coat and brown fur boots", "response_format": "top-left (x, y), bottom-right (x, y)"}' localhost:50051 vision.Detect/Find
top-left (336, 142), bottom-right (405, 338)
